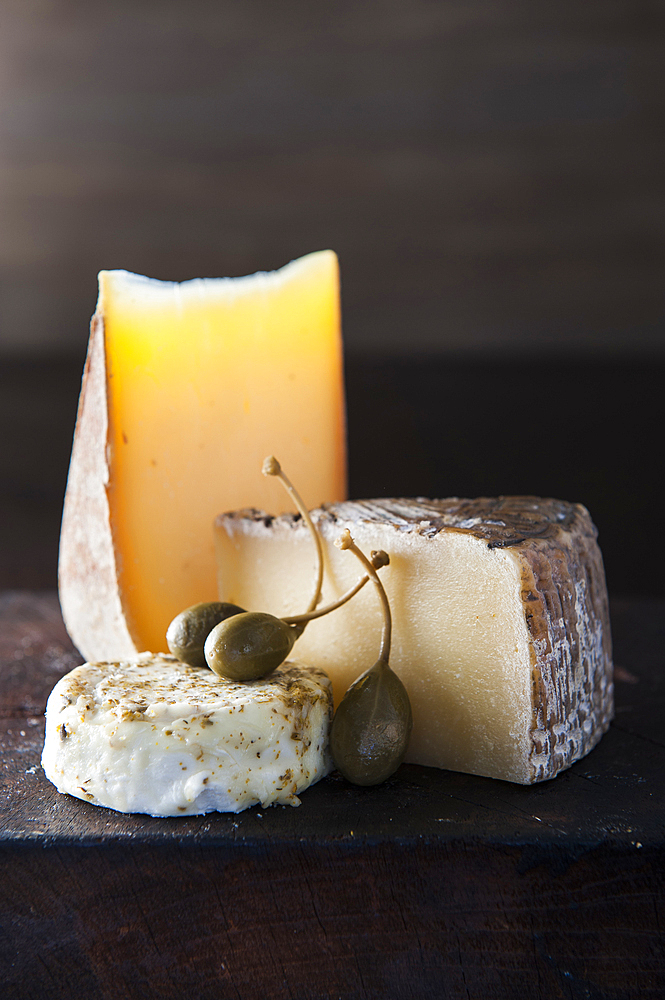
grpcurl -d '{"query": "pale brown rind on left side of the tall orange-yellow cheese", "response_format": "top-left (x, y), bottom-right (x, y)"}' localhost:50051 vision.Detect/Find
top-left (58, 313), bottom-right (139, 660)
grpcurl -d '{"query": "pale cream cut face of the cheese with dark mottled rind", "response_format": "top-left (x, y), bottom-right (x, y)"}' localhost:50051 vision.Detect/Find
top-left (216, 517), bottom-right (532, 783)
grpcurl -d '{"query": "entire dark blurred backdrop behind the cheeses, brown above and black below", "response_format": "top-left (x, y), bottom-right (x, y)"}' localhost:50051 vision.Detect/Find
top-left (0, 0), bottom-right (665, 596)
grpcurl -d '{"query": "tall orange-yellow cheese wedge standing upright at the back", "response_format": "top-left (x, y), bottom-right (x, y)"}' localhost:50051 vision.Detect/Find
top-left (59, 250), bottom-right (346, 660)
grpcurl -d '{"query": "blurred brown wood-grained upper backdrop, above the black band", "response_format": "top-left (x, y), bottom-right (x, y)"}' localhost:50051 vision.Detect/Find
top-left (0, 0), bottom-right (665, 355)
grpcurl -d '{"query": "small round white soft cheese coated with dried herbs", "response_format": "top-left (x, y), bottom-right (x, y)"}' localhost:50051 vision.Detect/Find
top-left (42, 654), bottom-right (332, 816)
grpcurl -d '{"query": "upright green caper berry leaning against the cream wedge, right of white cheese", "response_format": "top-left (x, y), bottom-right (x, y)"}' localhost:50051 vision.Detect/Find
top-left (330, 660), bottom-right (413, 785)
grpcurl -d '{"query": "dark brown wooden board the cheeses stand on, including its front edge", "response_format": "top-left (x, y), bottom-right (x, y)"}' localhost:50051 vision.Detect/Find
top-left (0, 592), bottom-right (665, 1000)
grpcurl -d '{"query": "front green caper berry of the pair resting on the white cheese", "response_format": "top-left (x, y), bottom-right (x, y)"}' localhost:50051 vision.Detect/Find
top-left (204, 611), bottom-right (302, 681)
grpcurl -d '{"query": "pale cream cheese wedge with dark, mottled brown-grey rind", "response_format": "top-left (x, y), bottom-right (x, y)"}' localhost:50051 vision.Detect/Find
top-left (216, 497), bottom-right (613, 784)
